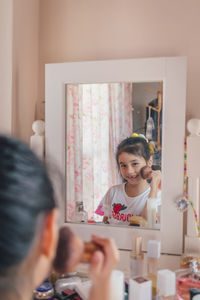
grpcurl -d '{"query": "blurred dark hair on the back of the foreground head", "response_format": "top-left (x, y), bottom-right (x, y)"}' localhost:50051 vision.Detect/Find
top-left (0, 135), bottom-right (56, 274)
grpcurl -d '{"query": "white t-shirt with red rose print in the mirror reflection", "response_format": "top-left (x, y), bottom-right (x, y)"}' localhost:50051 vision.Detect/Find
top-left (101, 183), bottom-right (161, 224)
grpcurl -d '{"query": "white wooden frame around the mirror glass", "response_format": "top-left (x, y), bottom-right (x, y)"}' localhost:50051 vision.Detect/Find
top-left (45, 57), bottom-right (186, 254)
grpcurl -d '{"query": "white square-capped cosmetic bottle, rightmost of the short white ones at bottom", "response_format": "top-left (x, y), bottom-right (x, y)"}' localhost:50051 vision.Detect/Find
top-left (156, 269), bottom-right (176, 300)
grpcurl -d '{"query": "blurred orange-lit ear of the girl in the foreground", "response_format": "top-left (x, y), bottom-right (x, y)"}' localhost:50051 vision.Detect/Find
top-left (41, 208), bottom-right (59, 259)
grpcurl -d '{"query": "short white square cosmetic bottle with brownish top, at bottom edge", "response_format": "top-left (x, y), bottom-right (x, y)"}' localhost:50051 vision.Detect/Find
top-left (128, 276), bottom-right (152, 300)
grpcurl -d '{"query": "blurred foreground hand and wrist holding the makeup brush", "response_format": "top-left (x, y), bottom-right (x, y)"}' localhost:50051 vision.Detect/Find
top-left (88, 235), bottom-right (119, 300)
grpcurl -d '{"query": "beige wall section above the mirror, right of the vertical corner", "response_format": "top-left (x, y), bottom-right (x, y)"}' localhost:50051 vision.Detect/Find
top-left (39, 0), bottom-right (200, 122)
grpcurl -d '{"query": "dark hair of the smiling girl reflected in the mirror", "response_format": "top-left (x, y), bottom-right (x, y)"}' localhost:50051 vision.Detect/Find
top-left (116, 137), bottom-right (151, 164)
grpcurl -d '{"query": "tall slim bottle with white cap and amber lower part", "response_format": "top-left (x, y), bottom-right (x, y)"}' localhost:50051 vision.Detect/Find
top-left (147, 240), bottom-right (161, 298)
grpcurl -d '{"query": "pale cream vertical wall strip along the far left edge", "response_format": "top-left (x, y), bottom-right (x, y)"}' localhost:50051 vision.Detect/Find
top-left (0, 0), bottom-right (13, 133)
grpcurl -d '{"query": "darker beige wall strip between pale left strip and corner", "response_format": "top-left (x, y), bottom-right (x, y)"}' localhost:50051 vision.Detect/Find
top-left (13, 0), bottom-right (39, 142)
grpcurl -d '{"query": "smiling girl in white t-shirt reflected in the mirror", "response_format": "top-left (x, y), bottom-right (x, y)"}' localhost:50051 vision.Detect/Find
top-left (102, 136), bottom-right (161, 224)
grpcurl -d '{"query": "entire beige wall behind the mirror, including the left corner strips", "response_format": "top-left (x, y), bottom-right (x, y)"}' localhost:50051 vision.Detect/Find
top-left (0, 0), bottom-right (200, 141)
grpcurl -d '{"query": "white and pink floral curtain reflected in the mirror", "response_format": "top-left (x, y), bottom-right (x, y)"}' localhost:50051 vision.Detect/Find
top-left (66, 83), bottom-right (133, 221)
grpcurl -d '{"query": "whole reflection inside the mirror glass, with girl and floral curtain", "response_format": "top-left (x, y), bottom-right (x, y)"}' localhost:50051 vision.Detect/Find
top-left (66, 82), bottom-right (162, 229)
